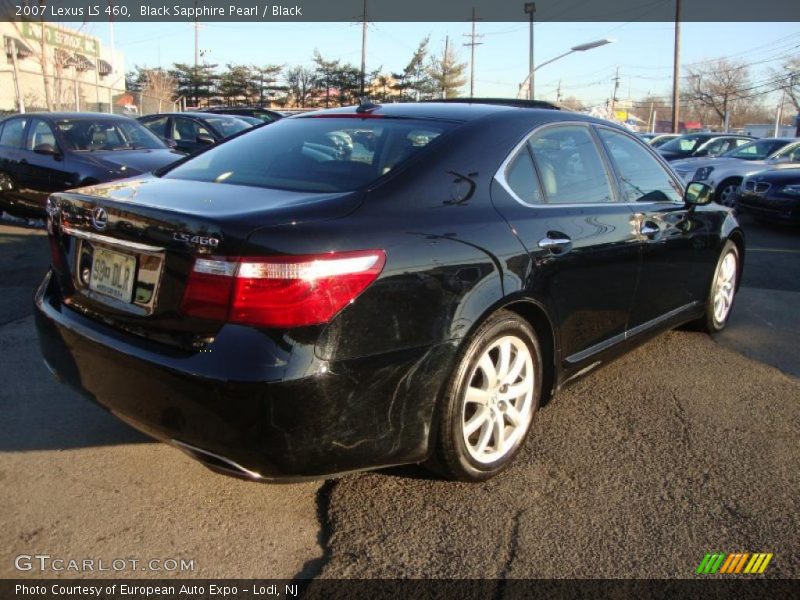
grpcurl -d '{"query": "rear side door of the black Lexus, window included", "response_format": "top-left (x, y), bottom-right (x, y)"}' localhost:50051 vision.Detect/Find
top-left (492, 123), bottom-right (639, 366)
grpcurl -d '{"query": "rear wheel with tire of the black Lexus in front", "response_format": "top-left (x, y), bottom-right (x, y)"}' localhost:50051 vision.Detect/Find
top-left (426, 310), bottom-right (542, 481)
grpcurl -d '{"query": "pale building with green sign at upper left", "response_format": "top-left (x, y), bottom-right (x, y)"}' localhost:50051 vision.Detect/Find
top-left (0, 21), bottom-right (125, 113)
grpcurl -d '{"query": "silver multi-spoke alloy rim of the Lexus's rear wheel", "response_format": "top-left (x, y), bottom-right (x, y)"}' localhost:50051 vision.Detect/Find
top-left (461, 335), bottom-right (535, 464)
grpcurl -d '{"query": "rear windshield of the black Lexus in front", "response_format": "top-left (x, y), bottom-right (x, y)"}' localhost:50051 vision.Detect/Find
top-left (164, 117), bottom-right (454, 192)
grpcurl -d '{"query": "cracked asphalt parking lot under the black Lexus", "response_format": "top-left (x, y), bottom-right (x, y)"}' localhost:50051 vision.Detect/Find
top-left (0, 213), bottom-right (800, 578)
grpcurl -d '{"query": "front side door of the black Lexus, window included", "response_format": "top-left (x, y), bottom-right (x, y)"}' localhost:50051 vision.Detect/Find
top-left (596, 126), bottom-right (714, 333)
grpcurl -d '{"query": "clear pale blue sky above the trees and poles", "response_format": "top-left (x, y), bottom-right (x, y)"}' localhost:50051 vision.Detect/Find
top-left (73, 17), bottom-right (800, 105)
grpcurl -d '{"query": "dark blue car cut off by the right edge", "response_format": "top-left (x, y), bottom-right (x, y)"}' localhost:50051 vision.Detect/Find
top-left (736, 169), bottom-right (800, 224)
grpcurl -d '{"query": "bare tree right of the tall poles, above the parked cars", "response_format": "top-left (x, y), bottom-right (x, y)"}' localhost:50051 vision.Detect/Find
top-left (684, 58), bottom-right (749, 124)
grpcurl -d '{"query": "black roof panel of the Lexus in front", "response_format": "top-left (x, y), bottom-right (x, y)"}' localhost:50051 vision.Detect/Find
top-left (294, 100), bottom-right (553, 121)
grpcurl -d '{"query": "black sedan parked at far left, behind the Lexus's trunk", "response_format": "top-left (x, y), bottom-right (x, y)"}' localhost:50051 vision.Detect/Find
top-left (0, 113), bottom-right (181, 217)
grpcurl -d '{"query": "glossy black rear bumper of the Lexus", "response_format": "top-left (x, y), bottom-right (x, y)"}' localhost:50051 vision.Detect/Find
top-left (34, 275), bottom-right (455, 479)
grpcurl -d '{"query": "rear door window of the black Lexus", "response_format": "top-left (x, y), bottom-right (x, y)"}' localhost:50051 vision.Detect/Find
top-left (528, 125), bottom-right (613, 204)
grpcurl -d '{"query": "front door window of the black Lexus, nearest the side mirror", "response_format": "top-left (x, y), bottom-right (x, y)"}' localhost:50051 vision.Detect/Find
top-left (597, 127), bottom-right (681, 202)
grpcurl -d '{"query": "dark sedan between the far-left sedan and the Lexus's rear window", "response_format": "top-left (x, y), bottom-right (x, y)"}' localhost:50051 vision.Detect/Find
top-left (139, 112), bottom-right (253, 154)
